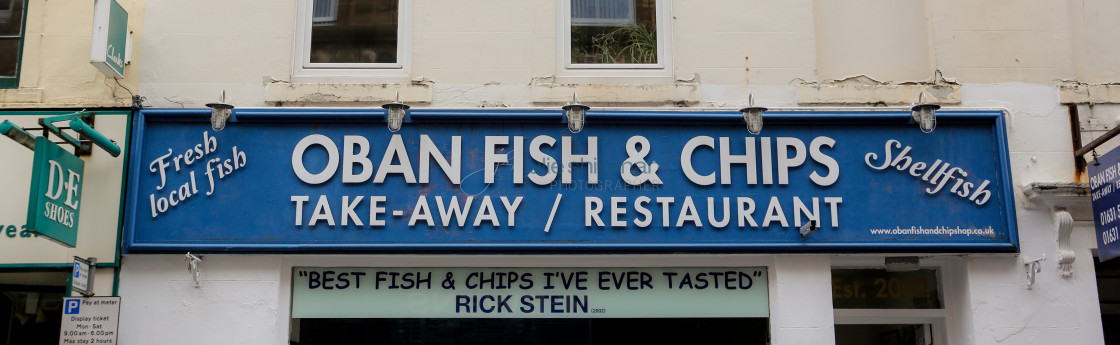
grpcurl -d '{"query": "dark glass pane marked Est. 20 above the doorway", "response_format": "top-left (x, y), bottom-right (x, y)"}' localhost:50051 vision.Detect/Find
top-left (832, 269), bottom-right (941, 309)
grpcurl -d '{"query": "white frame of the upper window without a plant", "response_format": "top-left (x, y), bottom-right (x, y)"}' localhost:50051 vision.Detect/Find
top-left (292, 0), bottom-right (412, 82)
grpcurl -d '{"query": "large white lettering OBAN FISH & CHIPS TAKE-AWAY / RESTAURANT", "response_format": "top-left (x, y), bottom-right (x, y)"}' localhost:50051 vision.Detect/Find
top-left (290, 134), bottom-right (843, 229)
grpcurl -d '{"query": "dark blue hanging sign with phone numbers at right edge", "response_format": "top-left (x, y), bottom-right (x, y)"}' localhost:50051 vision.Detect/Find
top-left (1089, 150), bottom-right (1120, 262)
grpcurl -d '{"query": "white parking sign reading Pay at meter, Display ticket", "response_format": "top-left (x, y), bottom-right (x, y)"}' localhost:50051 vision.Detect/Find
top-left (58, 297), bottom-right (121, 345)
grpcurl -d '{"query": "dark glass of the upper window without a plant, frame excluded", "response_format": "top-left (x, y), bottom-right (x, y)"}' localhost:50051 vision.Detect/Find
top-left (311, 0), bottom-right (398, 64)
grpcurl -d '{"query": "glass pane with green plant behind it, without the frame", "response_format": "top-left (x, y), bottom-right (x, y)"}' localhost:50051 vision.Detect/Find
top-left (571, 0), bottom-right (657, 64)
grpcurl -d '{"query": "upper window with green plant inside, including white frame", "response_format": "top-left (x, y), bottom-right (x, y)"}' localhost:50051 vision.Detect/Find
top-left (559, 0), bottom-right (671, 69)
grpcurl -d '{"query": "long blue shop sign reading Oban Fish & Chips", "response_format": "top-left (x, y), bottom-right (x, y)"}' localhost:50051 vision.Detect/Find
top-left (124, 109), bottom-right (1018, 253)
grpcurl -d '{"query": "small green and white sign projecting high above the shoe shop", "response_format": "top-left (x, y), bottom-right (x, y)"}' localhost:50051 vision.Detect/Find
top-left (90, 0), bottom-right (129, 77)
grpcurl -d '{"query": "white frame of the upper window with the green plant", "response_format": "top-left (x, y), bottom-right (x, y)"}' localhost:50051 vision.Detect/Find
top-left (557, 0), bottom-right (673, 77)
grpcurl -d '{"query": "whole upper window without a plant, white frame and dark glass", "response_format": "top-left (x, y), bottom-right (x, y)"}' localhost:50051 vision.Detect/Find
top-left (293, 0), bottom-right (411, 77)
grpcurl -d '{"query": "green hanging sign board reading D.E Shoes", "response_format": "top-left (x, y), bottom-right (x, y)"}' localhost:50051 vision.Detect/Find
top-left (27, 137), bottom-right (85, 248)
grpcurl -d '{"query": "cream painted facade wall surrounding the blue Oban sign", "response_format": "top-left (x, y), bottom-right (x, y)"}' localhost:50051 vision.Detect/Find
top-left (113, 0), bottom-right (1120, 344)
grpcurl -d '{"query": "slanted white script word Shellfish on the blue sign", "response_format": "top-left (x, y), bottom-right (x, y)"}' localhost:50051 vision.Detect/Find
top-left (864, 139), bottom-right (991, 205)
